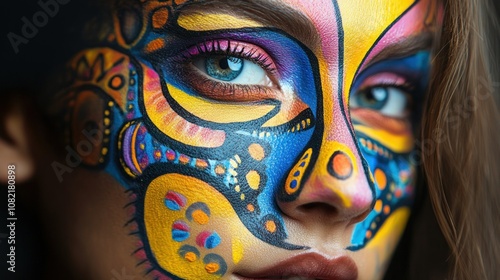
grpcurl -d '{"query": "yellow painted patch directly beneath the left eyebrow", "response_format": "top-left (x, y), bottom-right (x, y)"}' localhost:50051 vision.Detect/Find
top-left (177, 13), bottom-right (263, 31)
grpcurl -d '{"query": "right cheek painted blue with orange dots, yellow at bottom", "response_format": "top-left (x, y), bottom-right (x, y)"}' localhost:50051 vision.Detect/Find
top-left (352, 128), bottom-right (416, 247)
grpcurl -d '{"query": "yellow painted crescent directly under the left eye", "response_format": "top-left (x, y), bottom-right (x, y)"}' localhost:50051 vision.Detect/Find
top-left (167, 84), bottom-right (276, 124)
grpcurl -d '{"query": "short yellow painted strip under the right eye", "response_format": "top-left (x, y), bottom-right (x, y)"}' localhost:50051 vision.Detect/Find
top-left (354, 125), bottom-right (414, 153)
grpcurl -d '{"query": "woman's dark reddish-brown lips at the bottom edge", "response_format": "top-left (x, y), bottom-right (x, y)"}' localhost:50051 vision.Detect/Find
top-left (238, 253), bottom-right (358, 280)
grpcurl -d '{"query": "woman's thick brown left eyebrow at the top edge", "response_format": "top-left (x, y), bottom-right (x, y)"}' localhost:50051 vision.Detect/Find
top-left (179, 0), bottom-right (320, 50)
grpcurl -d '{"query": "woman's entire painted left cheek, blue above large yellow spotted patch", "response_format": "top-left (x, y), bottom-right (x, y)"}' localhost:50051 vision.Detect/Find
top-left (114, 56), bottom-right (314, 279)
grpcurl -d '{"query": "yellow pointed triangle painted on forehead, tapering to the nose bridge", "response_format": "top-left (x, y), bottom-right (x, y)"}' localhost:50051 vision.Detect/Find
top-left (338, 0), bottom-right (415, 98)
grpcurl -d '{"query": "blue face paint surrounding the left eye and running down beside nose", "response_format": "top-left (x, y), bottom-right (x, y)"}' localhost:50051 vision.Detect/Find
top-left (97, 29), bottom-right (321, 249)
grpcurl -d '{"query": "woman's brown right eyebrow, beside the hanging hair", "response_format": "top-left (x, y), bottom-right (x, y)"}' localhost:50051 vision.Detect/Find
top-left (363, 31), bottom-right (435, 69)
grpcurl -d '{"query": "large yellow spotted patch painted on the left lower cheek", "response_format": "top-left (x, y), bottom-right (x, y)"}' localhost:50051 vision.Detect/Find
top-left (138, 173), bottom-right (253, 279)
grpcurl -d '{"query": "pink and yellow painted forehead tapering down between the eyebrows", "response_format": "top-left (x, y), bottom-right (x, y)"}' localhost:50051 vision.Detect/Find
top-left (281, 0), bottom-right (439, 94)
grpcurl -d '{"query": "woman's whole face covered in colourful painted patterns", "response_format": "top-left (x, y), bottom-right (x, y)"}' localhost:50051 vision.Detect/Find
top-left (43, 0), bottom-right (440, 279)
